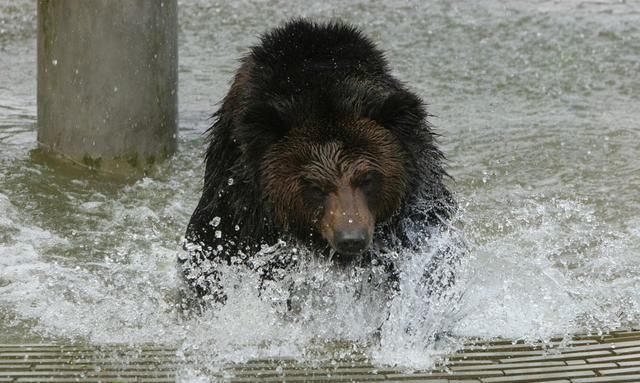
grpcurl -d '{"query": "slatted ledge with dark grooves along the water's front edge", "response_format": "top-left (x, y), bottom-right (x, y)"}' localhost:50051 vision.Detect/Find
top-left (0, 329), bottom-right (640, 383)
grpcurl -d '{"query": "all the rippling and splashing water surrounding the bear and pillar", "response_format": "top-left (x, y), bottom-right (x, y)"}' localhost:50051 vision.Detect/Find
top-left (0, 0), bottom-right (640, 376)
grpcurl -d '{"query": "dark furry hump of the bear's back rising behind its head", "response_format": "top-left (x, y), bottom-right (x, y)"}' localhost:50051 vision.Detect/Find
top-left (247, 20), bottom-right (394, 97)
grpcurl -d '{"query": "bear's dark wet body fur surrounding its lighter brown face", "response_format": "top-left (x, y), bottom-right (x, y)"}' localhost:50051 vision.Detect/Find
top-left (180, 20), bottom-right (455, 301)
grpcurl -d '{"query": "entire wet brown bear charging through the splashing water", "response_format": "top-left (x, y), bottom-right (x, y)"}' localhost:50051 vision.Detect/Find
top-left (179, 20), bottom-right (455, 301)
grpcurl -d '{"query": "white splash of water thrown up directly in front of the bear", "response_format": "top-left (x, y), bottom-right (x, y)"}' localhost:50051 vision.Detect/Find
top-left (175, 225), bottom-right (459, 369)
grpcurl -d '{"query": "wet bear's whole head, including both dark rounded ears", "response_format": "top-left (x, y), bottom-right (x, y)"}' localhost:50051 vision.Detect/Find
top-left (230, 82), bottom-right (431, 259)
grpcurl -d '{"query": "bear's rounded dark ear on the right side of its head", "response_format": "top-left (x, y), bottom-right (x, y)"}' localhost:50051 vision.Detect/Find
top-left (364, 91), bottom-right (427, 135)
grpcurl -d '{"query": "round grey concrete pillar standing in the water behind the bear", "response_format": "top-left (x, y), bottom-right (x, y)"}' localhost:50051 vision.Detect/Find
top-left (38, 0), bottom-right (178, 174)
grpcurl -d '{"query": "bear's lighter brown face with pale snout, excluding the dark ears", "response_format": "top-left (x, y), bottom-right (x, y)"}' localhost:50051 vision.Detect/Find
top-left (261, 118), bottom-right (408, 256)
